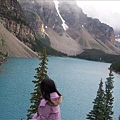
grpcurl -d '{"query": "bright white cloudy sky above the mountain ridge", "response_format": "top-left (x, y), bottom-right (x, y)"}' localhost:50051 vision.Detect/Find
top-left (76, 0), bottom-right (120, 29)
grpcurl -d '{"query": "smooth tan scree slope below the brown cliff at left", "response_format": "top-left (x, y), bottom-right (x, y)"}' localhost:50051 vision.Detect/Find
top-left (0, 23), bottom-right (37, 58)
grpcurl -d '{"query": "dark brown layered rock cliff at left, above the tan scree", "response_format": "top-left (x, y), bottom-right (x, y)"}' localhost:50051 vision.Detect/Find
top-left (0, 0), bottom-right (35, 49)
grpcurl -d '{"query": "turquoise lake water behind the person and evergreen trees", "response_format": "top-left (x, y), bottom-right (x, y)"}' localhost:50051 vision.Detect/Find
top-left (0, 57), bottom-right (120, 120)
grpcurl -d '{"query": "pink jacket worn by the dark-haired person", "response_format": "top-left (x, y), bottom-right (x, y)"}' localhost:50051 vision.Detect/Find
top-left (31, 92), bottom-right (61, 120)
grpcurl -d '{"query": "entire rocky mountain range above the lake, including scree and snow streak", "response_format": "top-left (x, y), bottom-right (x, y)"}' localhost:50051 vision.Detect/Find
top-left (0, 0), bottom-right (120, 57)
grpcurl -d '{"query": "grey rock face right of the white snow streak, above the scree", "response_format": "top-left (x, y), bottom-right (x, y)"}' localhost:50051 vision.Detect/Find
top-left (59, 2), bottom-right (115, 43)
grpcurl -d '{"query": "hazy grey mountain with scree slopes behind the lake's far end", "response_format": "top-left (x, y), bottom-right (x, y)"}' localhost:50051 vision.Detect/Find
top-left (19, 0), bottom-right (120, 55)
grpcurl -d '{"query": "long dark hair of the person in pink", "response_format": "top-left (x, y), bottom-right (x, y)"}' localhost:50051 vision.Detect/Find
top-left (40, 78), bottom-right (61, 103)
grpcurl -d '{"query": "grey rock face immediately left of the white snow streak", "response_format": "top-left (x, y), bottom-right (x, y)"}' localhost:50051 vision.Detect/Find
top-left (19, 0), bottom-right (64, 34)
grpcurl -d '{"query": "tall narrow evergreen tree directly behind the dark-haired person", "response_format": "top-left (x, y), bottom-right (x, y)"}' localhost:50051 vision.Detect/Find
top-left (27, 48), bottom-right (48, 117)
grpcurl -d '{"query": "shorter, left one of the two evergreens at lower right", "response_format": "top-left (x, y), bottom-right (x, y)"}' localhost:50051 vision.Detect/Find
top-left (86, 80), bottom-right (105, 120)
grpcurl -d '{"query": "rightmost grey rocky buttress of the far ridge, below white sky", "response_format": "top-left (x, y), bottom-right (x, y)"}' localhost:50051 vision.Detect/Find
top-left (85, 18), bottom-right (115, 44)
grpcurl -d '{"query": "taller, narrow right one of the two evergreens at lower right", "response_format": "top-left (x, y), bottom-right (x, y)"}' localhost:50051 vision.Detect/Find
top-left (104, 70), bottom-right (114, 120)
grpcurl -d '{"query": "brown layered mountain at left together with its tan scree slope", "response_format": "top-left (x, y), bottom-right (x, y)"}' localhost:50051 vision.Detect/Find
top-left (0, 0), bottom-right (37, 57)
